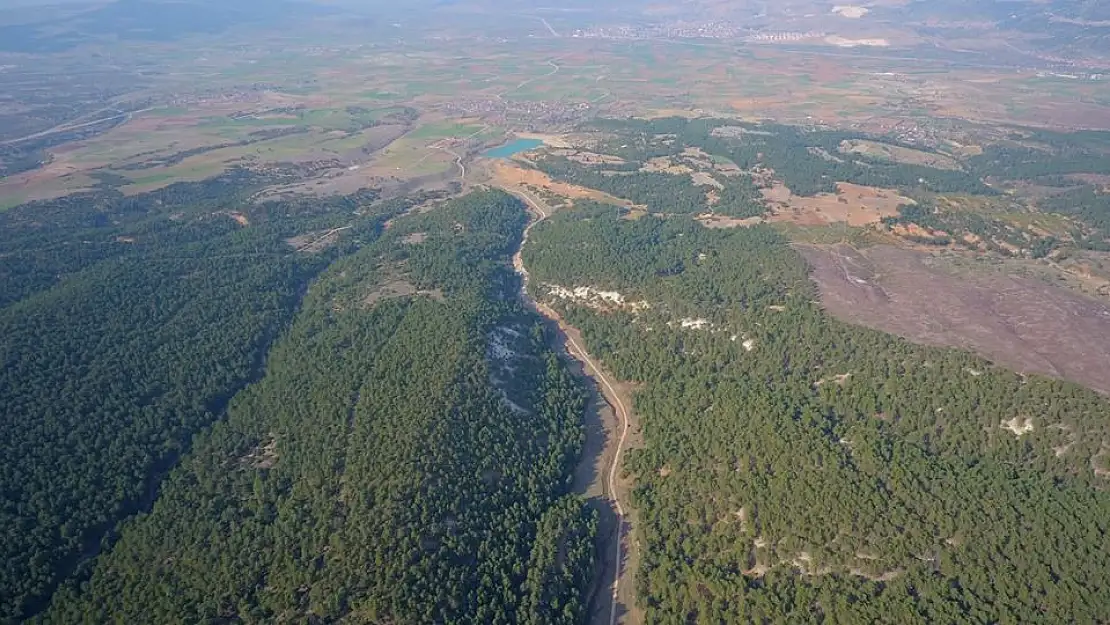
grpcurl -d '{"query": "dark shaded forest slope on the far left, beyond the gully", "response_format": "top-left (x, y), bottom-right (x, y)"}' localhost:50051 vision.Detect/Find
top-left (0, 172), bottom-right (428, 622)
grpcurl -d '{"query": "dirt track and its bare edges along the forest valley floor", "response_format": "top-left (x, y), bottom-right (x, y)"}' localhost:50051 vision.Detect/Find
top-left (504, 188), bottom-right (637, 625)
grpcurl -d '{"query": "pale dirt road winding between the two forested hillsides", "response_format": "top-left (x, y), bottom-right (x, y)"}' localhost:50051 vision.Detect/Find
top-left (506, 189), bottom-right (632, 625)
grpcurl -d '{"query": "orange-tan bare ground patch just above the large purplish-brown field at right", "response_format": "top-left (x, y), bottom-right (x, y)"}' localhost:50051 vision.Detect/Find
top-left (763, 182), bottom-right (915, 226)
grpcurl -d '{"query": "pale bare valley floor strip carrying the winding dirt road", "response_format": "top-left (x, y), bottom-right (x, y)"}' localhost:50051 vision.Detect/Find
top-left (508, 185), bottom-right (644, 625)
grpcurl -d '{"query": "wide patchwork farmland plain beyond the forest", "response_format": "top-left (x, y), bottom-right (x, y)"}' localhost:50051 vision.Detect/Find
top-left (0, 14), bottom-right (1110, 205)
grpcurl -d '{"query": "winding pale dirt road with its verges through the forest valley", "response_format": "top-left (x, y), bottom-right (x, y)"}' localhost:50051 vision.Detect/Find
top-left (505, 188), bottom-right (633, 625)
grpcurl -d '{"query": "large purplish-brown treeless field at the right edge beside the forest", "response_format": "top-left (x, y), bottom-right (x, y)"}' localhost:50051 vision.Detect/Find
top-left (799, 245), bottom-right (1110, 394)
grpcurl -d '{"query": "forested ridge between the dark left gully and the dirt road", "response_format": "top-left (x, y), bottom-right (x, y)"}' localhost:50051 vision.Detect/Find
top-left (34, 192), bottom-right (597, 625)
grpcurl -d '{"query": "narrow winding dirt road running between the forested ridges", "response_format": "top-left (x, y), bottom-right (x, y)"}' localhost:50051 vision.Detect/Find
top-left (506, 189), bottom-right (632, 625)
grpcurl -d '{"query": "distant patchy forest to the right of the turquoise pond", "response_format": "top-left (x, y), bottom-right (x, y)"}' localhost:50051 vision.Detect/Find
top-left (536, 118), bottom-right (1110, 259)
